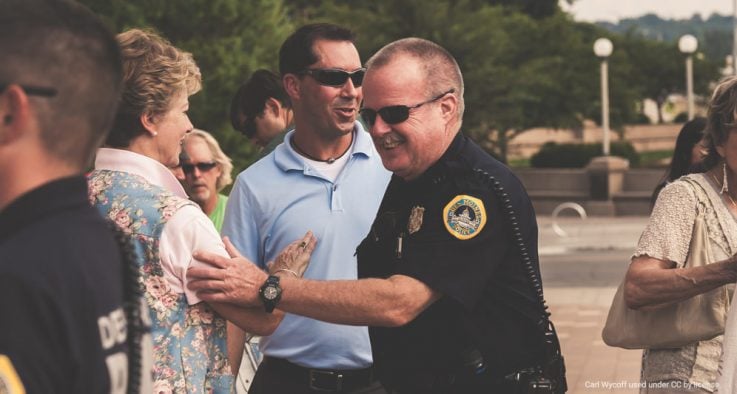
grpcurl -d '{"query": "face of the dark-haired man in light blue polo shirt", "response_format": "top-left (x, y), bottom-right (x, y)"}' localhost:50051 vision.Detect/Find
top-left (288, 40), bottom-right (363, 138)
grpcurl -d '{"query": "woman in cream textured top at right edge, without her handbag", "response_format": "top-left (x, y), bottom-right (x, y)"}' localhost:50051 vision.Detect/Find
top-left (624, 77), bottom-right (737, 393)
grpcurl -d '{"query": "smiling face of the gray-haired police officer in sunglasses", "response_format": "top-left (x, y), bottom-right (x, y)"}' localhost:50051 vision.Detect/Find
top-left (363, 55), bottom-right (456, 179)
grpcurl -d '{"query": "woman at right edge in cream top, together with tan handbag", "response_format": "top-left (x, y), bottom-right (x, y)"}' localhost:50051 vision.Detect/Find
top-left (604, 77), bottom-right (737, 393)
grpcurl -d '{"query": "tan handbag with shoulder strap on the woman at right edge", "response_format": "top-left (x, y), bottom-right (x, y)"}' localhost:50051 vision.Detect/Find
top-left (601, 181), bottom-right (729, 349)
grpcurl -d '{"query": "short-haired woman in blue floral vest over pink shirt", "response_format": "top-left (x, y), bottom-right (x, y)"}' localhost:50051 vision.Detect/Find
top-left (89, 29), bottom-right (315, 393)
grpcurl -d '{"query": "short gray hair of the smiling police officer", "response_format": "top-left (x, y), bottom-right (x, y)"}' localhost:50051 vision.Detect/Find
top-left (366, 37), bottom-right (465, 126)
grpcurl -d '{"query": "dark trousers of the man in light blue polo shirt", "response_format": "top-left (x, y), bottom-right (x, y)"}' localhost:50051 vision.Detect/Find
top-left (248, 357), bottom-right (387, 394)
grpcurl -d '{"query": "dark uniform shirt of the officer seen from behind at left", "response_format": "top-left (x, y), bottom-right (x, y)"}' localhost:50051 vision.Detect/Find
top-left (0, 177), bottom-right (128, 394)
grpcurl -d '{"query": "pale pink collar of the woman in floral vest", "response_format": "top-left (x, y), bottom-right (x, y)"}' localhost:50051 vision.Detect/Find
top-left (95, 148), bottom-right (188, 198)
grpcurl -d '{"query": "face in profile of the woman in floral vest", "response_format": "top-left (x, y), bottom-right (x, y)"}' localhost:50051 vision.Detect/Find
top-left (152, 90), bottom-right (193, 167)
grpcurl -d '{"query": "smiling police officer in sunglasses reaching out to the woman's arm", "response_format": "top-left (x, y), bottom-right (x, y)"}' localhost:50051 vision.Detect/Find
top-left (189, 38), bottom-right (566, 393)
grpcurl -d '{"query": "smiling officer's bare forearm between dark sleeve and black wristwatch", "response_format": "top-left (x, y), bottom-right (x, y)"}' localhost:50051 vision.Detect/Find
top-left (277, 275), bottom-right (441, 327)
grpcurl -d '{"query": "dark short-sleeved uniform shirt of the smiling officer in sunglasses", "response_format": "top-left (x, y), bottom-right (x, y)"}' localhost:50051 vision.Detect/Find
top-left (358, 132), bottom-right (543, 387)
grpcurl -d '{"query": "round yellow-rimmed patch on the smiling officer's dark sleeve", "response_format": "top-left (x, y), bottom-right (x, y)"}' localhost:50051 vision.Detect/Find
top-left (443, 194), bottom-right (486, 240)
